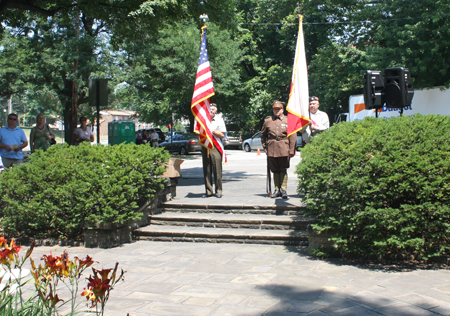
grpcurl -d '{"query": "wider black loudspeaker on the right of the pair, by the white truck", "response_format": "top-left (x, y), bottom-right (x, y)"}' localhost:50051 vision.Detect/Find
top-left (384, 67), bottom-right (414, 108)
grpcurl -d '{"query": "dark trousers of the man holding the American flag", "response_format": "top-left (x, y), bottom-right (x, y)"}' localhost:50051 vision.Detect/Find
top-left (202, 147), bottom-right (222, 195)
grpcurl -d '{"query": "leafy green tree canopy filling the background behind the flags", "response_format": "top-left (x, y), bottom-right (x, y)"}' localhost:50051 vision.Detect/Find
top-left (0, 0), bottom-right (450, 135)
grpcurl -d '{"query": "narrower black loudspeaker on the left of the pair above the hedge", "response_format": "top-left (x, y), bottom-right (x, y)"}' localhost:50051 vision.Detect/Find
top-left (364, 70), bottom-right (384, 110)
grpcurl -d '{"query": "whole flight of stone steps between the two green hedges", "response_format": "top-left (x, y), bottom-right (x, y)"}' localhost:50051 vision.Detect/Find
top-left (133, 203), bottom-right (314, 246)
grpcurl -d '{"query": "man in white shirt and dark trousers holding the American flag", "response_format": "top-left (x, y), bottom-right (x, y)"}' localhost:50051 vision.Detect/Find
top-left (202, 103), bottom-right (227, 198)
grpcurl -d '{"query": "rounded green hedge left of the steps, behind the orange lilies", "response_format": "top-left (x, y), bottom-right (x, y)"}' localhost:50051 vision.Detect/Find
top-left (0, 143), bottom-right (169, 238)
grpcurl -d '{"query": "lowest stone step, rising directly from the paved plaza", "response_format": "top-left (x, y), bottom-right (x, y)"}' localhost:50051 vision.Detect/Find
top-left (134, 225), bottom-right (308, 246)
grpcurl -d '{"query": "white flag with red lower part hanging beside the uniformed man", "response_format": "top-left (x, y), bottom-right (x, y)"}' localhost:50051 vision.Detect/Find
top-left (286, 15), bottom-right (310, 137)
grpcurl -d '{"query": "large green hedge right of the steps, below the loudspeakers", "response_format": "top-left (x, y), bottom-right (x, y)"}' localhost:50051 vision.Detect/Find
top-left (296, 115), bottom-right (450, 259)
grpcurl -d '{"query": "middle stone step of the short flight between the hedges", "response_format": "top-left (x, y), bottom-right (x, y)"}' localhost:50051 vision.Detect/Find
top-left (149, 212), bottom-right (312, 230)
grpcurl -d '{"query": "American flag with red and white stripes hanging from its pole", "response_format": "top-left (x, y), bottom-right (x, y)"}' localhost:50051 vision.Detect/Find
top-left (191, 26), bottom-right (214, 149)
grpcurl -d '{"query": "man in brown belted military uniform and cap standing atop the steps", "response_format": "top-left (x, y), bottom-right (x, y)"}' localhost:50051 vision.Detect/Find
top-left (261, 101), bottom-right (297, 199)
